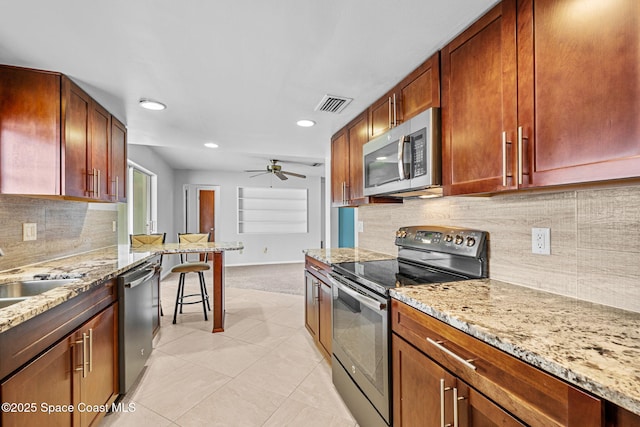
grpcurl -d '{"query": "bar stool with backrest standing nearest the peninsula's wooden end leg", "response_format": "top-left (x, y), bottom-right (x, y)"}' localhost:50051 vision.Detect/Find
top-left (171, 233), bottom-right (211, 324)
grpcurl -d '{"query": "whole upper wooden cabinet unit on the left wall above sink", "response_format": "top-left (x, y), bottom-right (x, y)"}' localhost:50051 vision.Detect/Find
top-left (0, 66), bottom-right (126, 201)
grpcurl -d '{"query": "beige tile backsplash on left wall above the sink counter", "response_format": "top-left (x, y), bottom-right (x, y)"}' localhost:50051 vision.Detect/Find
top-left (0, 195), bottom-right (118, 271)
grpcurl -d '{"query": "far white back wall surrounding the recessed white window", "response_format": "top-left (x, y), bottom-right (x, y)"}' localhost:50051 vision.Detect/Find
top-left (172, 170), bottom-right (324, 265)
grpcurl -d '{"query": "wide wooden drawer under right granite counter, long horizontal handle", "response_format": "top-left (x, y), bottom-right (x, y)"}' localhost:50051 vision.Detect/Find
top-left (391, 300), bottom-right (604, 427)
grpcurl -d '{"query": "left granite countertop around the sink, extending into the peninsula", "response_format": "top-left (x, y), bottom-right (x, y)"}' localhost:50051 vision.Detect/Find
top-left (0, 242), bottom-right (243, 333)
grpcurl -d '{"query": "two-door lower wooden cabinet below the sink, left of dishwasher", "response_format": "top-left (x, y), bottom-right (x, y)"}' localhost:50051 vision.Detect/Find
top-left (0, 302), bottom-right (118, 427)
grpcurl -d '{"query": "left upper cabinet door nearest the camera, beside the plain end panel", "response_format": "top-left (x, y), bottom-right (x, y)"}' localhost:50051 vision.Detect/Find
top-left (62, 78), bottom-right (94, 198)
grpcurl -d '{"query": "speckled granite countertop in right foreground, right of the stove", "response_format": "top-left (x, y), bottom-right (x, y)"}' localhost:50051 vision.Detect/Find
top-left (391, 279), bottom-right (640, 415)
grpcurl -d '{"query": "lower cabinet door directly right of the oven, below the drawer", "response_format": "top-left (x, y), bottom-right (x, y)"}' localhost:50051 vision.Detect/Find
top-left (391, 334), bottom-right (455, 427)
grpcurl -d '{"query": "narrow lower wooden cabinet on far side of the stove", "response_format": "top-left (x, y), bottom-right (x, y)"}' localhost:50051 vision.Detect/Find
top-left (305, 256), bottom-right (333, 360)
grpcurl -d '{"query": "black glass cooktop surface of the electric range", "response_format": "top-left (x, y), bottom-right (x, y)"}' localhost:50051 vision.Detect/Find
top-left (333, 259), bottom-right (469, 295)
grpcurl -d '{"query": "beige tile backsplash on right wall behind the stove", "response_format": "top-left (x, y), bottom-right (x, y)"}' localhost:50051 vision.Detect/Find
top-left (358, 185), bottom-right (640, 312)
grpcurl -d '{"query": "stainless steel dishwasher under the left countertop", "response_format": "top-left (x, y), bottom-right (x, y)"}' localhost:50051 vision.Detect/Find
top-left (118, 257), bottom-right (160, 394)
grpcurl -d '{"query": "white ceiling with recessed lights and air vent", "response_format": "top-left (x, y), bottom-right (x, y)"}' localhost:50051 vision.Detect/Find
top-left (0, 0), bottom-right (496, 175)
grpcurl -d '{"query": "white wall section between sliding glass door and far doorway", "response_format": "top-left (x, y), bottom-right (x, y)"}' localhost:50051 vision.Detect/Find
top-left (127, 144), bottom-right (182, 272)
